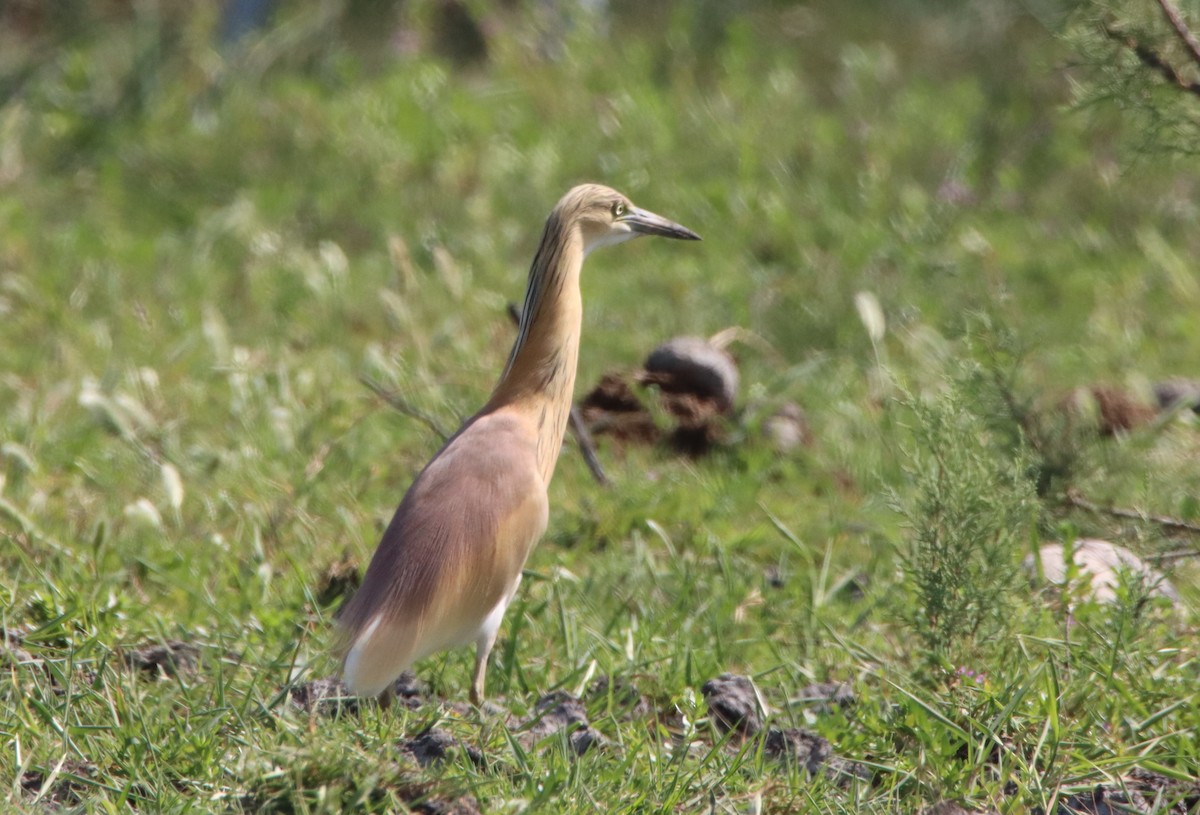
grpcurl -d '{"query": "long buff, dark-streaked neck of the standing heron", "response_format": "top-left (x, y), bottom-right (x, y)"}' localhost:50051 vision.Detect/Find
top-left (485, 218), bottom-right (583, 485)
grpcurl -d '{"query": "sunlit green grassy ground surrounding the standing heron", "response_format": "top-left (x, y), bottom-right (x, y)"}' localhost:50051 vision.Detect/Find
top-left (0, 4), bottom-right (1200, 813)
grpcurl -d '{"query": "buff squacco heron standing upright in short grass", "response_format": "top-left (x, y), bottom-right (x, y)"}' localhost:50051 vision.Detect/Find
top-left (338, 184), bottom-right (700, 705)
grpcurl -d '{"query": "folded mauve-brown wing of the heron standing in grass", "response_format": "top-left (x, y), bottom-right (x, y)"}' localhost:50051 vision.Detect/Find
top-left (338, 413), bottom-right (548, 694)
